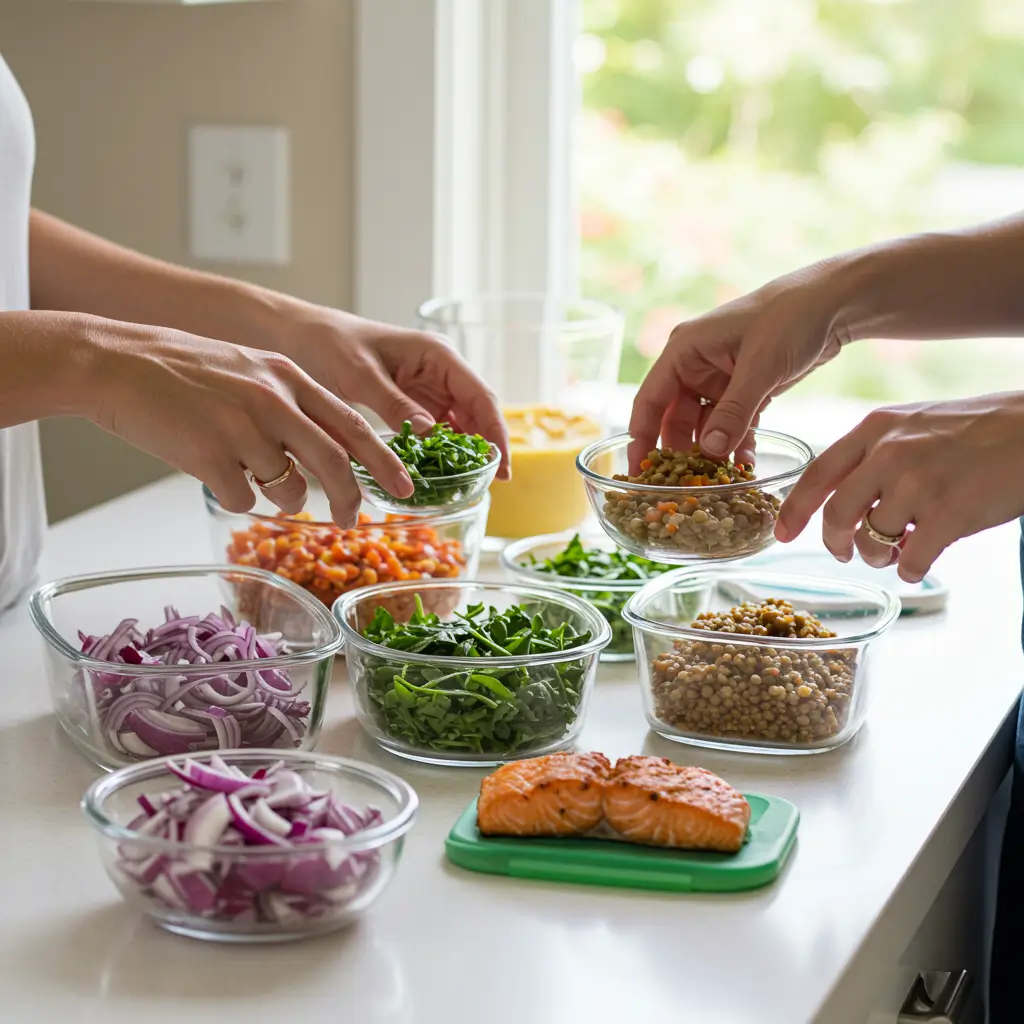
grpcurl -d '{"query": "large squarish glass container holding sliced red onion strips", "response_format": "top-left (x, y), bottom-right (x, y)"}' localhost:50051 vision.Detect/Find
top-left (29, 565), bottom-right (341, 770)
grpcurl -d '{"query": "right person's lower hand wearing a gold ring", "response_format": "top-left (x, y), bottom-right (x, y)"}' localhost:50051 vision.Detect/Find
top-left (775, 391), bottom-right (1024, 583)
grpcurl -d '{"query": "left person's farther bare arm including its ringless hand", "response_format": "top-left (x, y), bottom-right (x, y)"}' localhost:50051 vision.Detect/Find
top-left (30, 210), bottom-right (510, 479)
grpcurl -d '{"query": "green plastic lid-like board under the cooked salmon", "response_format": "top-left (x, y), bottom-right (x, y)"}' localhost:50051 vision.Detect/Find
top-left (444, 794), bottom-right (800, 893)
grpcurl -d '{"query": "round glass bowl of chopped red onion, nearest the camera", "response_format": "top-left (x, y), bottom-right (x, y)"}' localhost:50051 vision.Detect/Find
top-left (82, 750), bottom-right (419, 943)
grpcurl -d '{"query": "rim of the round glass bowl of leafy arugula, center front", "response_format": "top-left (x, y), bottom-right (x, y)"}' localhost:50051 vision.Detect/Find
top-left (331, 579), bottom-right (611, 669)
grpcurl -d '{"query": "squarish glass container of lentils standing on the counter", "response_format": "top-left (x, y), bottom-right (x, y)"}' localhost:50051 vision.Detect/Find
top-left (623, 566), bottom-right (900, 754)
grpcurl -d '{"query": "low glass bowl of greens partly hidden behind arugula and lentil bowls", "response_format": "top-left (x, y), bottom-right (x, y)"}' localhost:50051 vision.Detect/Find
top-left (501, 534), bottom-right (684, 662)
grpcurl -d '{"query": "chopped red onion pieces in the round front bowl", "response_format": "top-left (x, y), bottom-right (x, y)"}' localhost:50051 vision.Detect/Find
top-left (118, 755), bottom-right (384, 926)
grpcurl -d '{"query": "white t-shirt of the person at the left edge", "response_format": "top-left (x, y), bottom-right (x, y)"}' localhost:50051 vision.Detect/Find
top-left (0, 56), bottom-right (46, 609)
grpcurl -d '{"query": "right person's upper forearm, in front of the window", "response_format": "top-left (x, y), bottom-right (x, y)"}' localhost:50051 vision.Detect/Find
top-left (829, 215), bottom-right (1024, 339)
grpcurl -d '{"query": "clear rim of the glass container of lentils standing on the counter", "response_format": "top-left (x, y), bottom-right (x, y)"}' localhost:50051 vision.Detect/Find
top-left (622, 565), bottom-right (900, 650)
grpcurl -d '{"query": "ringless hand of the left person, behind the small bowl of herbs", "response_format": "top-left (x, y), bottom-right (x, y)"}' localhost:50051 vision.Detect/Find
top-left (260, 304), bottom-right (512, 480)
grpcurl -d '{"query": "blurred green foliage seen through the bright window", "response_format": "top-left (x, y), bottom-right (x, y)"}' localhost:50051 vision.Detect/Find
top-left (577, 0), bottom-right (1024, 401)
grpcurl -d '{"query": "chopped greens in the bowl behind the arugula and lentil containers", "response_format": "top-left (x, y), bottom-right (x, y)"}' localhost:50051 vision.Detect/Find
top-left (526, 534), bottom-right (677, 654)
